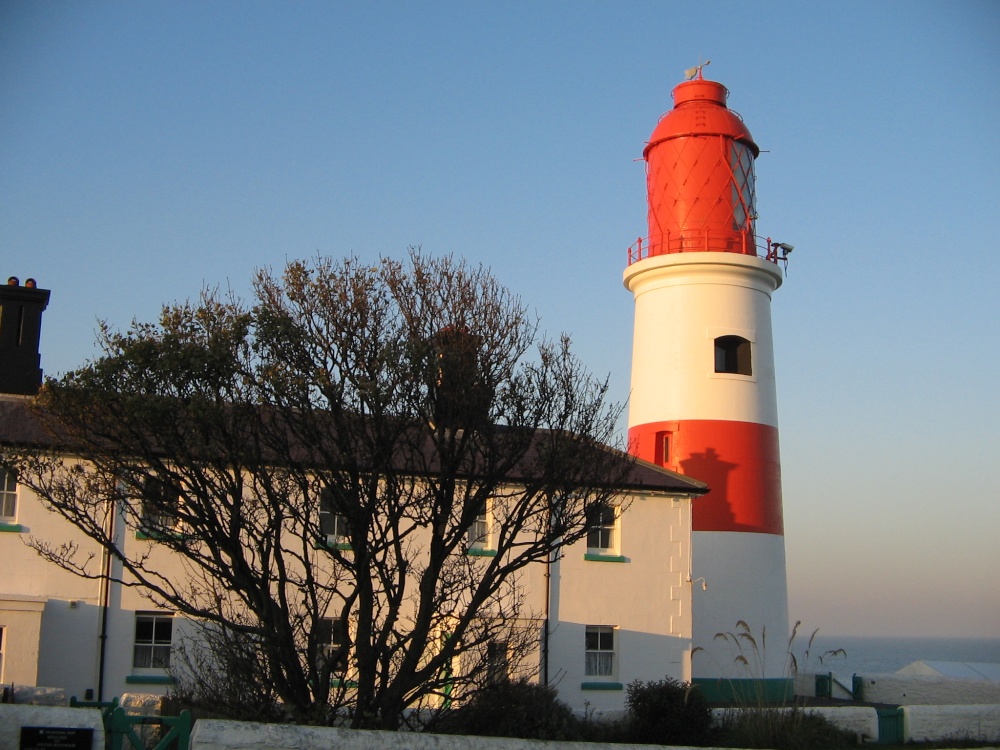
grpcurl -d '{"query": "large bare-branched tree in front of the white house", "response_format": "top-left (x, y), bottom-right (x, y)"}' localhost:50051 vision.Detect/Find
top-left (7, 251), bottom-right (631, 728)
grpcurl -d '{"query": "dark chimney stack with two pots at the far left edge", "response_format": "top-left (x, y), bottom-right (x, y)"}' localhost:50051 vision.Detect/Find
top-left (0, 276), bottom-right (50, 396)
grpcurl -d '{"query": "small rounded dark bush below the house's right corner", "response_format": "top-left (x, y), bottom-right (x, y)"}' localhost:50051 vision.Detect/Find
top-left (625, 677), bottom-right (712, 745)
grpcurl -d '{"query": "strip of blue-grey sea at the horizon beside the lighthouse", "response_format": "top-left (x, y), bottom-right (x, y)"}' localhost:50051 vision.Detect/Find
top-left (792, 632), bottom-right (1000, 685)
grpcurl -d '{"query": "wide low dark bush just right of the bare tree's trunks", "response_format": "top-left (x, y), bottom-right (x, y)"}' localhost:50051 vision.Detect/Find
top-left (432, 680), bottom-right (580, 740)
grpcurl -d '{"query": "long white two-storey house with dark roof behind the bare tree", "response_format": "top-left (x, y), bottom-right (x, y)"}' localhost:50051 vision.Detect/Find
top-left (0, 276), bottom-right (705, 711)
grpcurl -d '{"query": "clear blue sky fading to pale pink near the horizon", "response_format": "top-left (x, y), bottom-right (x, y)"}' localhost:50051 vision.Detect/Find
top-left (0, 0), bottom-right (1000, 637)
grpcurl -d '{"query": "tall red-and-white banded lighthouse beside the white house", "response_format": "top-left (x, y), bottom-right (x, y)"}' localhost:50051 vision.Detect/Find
top-left (624, 69), bottom-right (791, 695)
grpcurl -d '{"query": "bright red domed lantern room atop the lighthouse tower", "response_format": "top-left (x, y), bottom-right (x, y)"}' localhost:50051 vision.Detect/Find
top-left (629, 70), bottom-right (760, 262)
